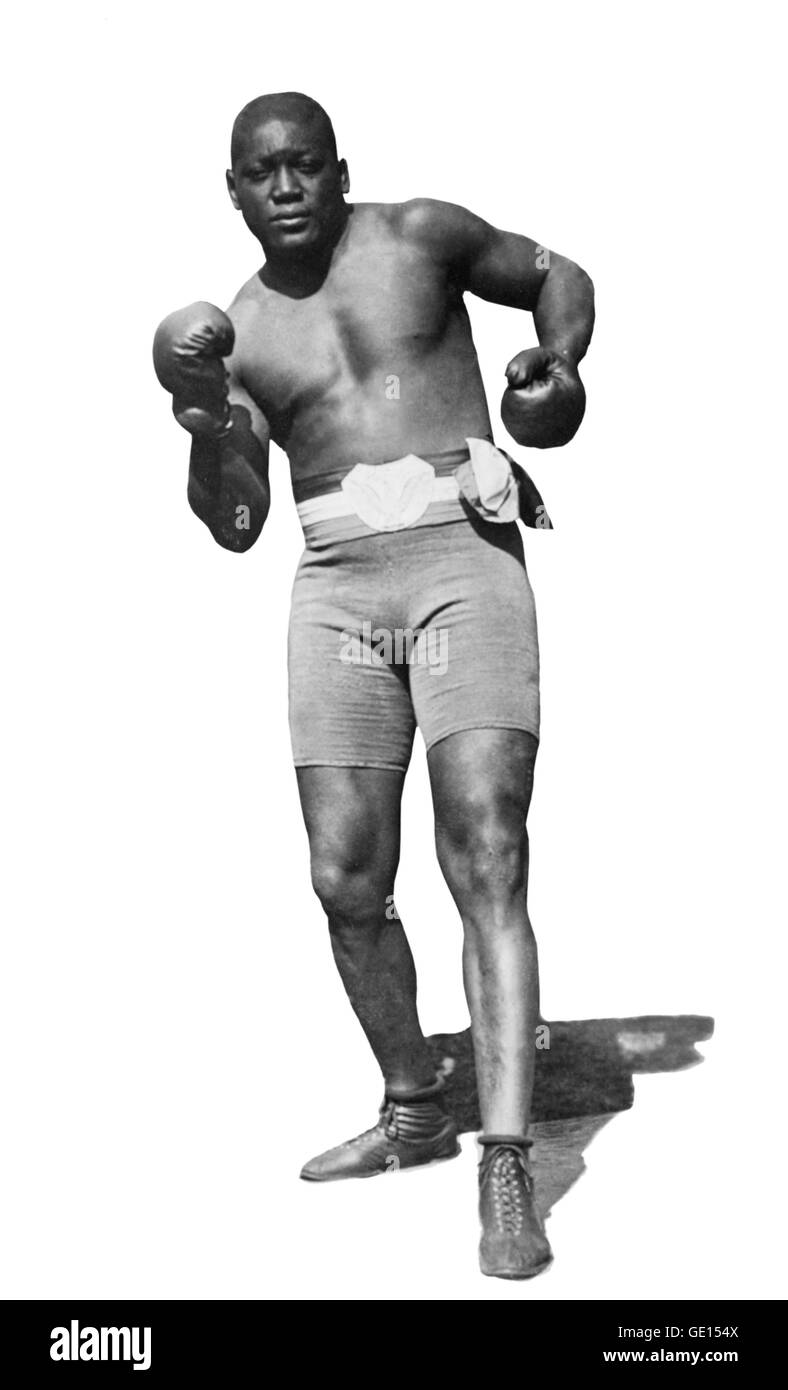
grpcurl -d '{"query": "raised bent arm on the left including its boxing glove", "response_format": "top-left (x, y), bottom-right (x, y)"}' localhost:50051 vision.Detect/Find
top-left (153, 302), bottom-right (270, 550)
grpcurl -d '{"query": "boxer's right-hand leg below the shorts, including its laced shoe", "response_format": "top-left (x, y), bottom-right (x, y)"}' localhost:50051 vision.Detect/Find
top-left (429, 728), bottom-right (552, 1279)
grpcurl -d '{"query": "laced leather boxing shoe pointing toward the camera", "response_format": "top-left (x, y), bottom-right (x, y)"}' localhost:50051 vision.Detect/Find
top-left (479, 1134), bottom-right (553, 1279)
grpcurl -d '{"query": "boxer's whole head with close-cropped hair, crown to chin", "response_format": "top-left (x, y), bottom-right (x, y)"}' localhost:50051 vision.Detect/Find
top-left (227, 92), bottom-right (350, 257)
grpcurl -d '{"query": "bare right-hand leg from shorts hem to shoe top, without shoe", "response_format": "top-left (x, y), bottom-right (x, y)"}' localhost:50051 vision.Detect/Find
top-left (429, 728), bottom-right (539, 1136)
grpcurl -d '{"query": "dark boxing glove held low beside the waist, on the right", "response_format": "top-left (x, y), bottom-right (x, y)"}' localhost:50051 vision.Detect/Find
top-left (500, 348), bottom-right (585, 449)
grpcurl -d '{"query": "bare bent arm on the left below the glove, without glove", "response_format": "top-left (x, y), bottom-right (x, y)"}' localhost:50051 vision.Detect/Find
top-left (188, 366), bottom-right (271, 552)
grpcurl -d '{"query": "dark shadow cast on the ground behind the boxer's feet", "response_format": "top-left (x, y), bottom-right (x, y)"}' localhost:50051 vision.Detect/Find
top-left (427, 1013), bottom-right (714, 1216)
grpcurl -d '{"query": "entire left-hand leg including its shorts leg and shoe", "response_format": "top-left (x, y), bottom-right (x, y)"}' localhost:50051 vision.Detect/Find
top-left (289, 537), bottom-right (459, 1182)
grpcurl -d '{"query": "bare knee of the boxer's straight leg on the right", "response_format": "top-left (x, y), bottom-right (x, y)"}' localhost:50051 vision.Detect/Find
top-left (438, 817), bottom-right (528, 909)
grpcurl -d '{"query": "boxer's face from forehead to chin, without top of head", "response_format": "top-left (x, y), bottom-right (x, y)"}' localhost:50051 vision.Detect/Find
top-left (227, 117), bottom-right (350, 256)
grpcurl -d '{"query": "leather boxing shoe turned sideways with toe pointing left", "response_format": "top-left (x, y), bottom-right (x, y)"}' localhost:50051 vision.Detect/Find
top-left (300, 1077), bottom-right (460, 1183)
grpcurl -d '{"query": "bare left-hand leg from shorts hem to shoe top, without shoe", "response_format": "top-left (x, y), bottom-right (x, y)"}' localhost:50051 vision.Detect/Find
top-left (297, 767), bottom-right (435, 1091)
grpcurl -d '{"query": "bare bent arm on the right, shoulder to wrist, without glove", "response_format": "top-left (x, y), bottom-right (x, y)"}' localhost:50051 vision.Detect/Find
top-left (404, 199), bottom-right (593, 363)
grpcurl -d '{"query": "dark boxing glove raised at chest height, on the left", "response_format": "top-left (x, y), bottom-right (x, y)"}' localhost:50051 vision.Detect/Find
top-left (153, 300), bottom-right (235, 438)
